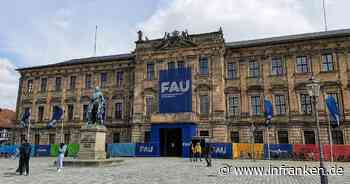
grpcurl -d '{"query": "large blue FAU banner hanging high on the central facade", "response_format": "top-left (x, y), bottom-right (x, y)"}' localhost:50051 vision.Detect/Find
top-left (159, 68), bottom-right (192, 113)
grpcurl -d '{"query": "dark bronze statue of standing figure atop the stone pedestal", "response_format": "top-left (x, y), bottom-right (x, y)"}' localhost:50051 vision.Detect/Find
top-left (87, 87), bottom-right (106, 125)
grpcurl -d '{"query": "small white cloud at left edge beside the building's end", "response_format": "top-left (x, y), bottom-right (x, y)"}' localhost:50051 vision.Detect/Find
top-left (0, 58), bottom-right (19, 109)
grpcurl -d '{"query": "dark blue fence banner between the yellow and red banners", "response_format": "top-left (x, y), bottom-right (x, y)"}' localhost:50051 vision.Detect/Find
top-left (264, 144), bottom-right (293, 159)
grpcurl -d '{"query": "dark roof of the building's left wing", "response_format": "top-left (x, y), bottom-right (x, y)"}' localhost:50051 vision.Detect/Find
top-left (17, 53), bottom-right (134, 71)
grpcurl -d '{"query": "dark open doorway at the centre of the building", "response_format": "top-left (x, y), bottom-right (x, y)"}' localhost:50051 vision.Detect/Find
top-left (159, 128), bottom-right (182, 156)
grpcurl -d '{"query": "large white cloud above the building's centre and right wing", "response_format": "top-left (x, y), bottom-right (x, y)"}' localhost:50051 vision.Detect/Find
top-left (139, 0), bottom-right (317, 41)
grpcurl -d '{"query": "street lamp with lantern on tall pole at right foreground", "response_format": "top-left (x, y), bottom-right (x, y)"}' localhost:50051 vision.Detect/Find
top-left (306, 76), bottom-right (328, 184)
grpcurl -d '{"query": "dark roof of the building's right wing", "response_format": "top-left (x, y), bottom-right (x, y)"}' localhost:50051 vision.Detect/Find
top-left (225, 29), bottom-right (350, 48)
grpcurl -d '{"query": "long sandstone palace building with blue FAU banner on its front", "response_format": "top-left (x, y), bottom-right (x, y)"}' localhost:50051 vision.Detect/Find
top-left (17, 28), bottom-right (350, 155)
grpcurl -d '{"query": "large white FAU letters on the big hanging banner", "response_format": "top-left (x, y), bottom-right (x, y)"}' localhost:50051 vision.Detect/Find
top-left (160, 80), bottom-right (190, 93)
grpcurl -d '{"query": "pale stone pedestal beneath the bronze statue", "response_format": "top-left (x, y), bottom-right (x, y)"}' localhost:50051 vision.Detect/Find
top-left (78, 125), bottom-right (107, 160)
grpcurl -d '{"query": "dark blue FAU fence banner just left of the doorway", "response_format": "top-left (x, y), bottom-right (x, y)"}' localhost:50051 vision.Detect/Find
top-left (135, 143), bottom-right (160, 157)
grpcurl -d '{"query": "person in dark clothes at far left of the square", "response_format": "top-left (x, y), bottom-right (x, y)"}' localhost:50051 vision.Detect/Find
top-left (19, 138), bottom-right (32, 176)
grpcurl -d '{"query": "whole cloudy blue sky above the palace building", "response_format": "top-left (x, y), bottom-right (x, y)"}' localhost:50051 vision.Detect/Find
top-left (0, 0), bottom-right (350, 109)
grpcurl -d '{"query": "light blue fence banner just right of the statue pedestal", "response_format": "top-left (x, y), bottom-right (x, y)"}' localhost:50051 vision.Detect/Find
top-left (107, 143), bottom-right (136, 157)
